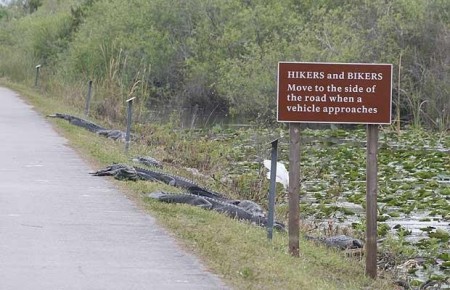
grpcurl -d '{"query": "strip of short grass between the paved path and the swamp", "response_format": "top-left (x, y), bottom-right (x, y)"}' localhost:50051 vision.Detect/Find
top-left (3, 80), bottom-right (395, 290)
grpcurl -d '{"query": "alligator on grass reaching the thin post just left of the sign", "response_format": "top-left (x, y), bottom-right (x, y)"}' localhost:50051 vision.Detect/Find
top-left (147, 191), bottom-right (285, 231)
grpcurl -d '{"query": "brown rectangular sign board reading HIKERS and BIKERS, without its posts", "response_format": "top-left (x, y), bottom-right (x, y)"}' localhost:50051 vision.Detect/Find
top-left (277, 62), bottom-right (392, 124)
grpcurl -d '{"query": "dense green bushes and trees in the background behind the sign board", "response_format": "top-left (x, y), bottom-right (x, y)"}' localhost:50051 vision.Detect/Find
top-left (0, 0), bottom-right (450, 130)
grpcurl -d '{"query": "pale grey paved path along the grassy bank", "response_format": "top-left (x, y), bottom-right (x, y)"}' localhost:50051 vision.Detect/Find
top-left (0, 87), bottom-right (225, 290)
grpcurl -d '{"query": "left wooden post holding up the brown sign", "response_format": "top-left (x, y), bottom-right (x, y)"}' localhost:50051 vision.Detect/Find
top-left (288, 123), bottom-right (300, 257)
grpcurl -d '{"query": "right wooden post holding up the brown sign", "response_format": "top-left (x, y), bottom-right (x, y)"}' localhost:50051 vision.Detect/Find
top-left (366, 124), bottom-right (378, 279)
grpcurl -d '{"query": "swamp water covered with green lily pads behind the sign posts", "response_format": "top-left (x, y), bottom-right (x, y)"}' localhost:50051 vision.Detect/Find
top-left (229, 129), bottom-right (450, 289)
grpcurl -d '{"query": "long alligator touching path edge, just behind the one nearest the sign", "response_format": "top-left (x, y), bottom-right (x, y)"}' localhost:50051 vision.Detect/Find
top-left (91, 164), bottom-right (223, 198)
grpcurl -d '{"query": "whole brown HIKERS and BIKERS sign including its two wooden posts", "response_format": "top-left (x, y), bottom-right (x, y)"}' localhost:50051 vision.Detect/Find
top-left (277, 62), bottom-right (392, 278)
